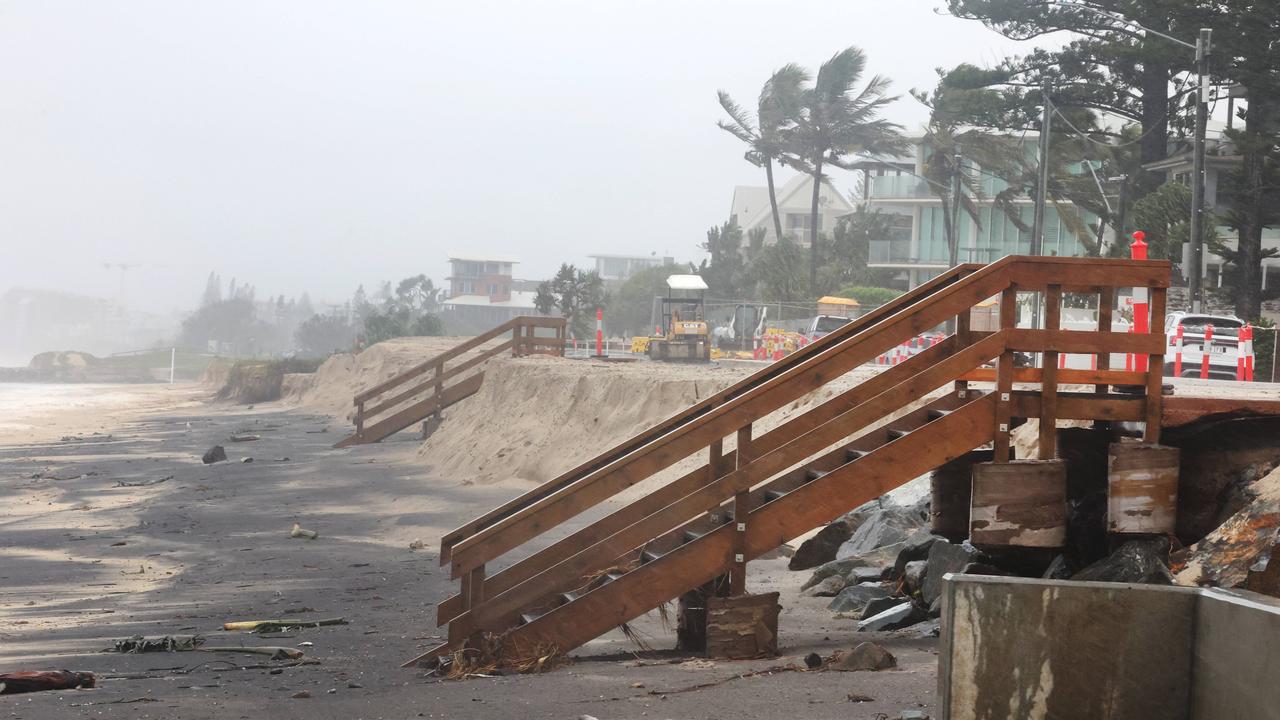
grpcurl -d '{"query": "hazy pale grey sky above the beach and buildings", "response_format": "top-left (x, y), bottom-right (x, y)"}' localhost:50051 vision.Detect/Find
top-left (0, 0), bottom-right (1059, 310)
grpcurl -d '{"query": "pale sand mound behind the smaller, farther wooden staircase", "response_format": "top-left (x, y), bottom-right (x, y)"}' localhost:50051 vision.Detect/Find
top-left (280, 337), bottom-right (467, 420)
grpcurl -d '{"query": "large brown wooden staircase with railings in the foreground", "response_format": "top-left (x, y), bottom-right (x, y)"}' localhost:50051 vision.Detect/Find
top-left (406, 256), bottom-right (1170, 666)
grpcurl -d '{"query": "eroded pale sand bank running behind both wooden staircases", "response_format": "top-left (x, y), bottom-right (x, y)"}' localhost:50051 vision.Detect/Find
top-left (284, 338), bottom-right (921, 481)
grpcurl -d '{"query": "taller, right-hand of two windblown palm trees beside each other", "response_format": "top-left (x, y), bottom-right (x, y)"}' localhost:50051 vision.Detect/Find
top-left (787, 47), bottom-right (906, 295)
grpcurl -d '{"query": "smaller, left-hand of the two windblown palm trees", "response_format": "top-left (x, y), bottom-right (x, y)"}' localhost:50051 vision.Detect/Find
top-left (716, 63), bottom-right (809, 240)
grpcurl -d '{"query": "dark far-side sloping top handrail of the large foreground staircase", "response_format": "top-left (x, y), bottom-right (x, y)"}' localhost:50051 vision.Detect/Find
top-left (440, 260), bottom-right (983, 565)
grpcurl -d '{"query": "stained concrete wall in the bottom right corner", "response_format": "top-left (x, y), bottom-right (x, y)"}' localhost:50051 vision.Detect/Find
top-left (938, 575), bottom-right (1280, 720)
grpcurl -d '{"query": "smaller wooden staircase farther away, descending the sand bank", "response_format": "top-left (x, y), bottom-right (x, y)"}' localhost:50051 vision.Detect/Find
top-left (334, 316), bottom-right (566, 447)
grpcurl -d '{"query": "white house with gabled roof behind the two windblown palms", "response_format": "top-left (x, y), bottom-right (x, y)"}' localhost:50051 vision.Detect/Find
top-left (730, 174), bottom-right (854, 246)
